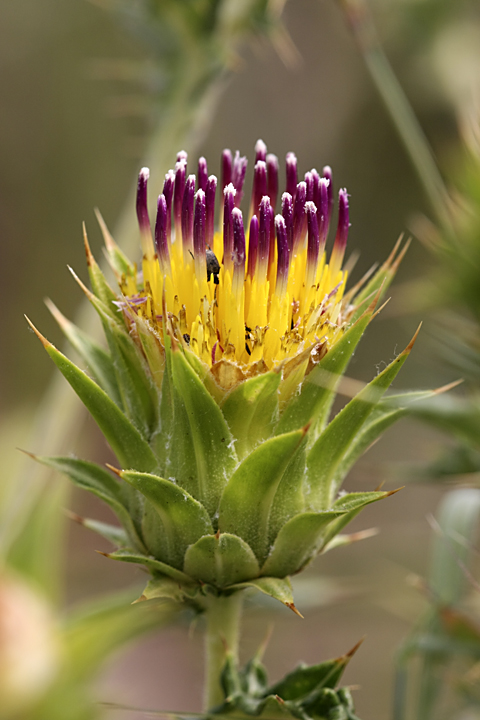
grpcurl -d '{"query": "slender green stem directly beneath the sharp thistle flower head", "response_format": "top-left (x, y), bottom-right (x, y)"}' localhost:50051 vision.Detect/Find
top-left (204, 592), bottom-right (243, 711)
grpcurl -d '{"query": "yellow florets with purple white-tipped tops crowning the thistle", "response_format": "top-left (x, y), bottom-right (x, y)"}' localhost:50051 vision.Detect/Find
top-left (121, 141), bottom-right (353, 388)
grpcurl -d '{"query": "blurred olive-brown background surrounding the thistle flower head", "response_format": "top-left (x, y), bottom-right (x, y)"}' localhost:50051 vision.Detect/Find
top-left (0, 0), bottom-right (480, 720)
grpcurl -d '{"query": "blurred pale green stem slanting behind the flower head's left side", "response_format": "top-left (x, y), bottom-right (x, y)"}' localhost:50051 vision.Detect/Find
top-left (0, 0), bottom-right (295, 576)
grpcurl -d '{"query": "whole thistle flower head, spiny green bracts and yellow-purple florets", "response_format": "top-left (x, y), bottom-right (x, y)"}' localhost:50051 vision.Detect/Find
top-left (27, 141), bottom-right (418, 607)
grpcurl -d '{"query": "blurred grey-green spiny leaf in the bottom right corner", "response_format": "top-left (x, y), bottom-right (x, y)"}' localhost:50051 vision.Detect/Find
top-left (394, 489), bottom-right (480, 720)
